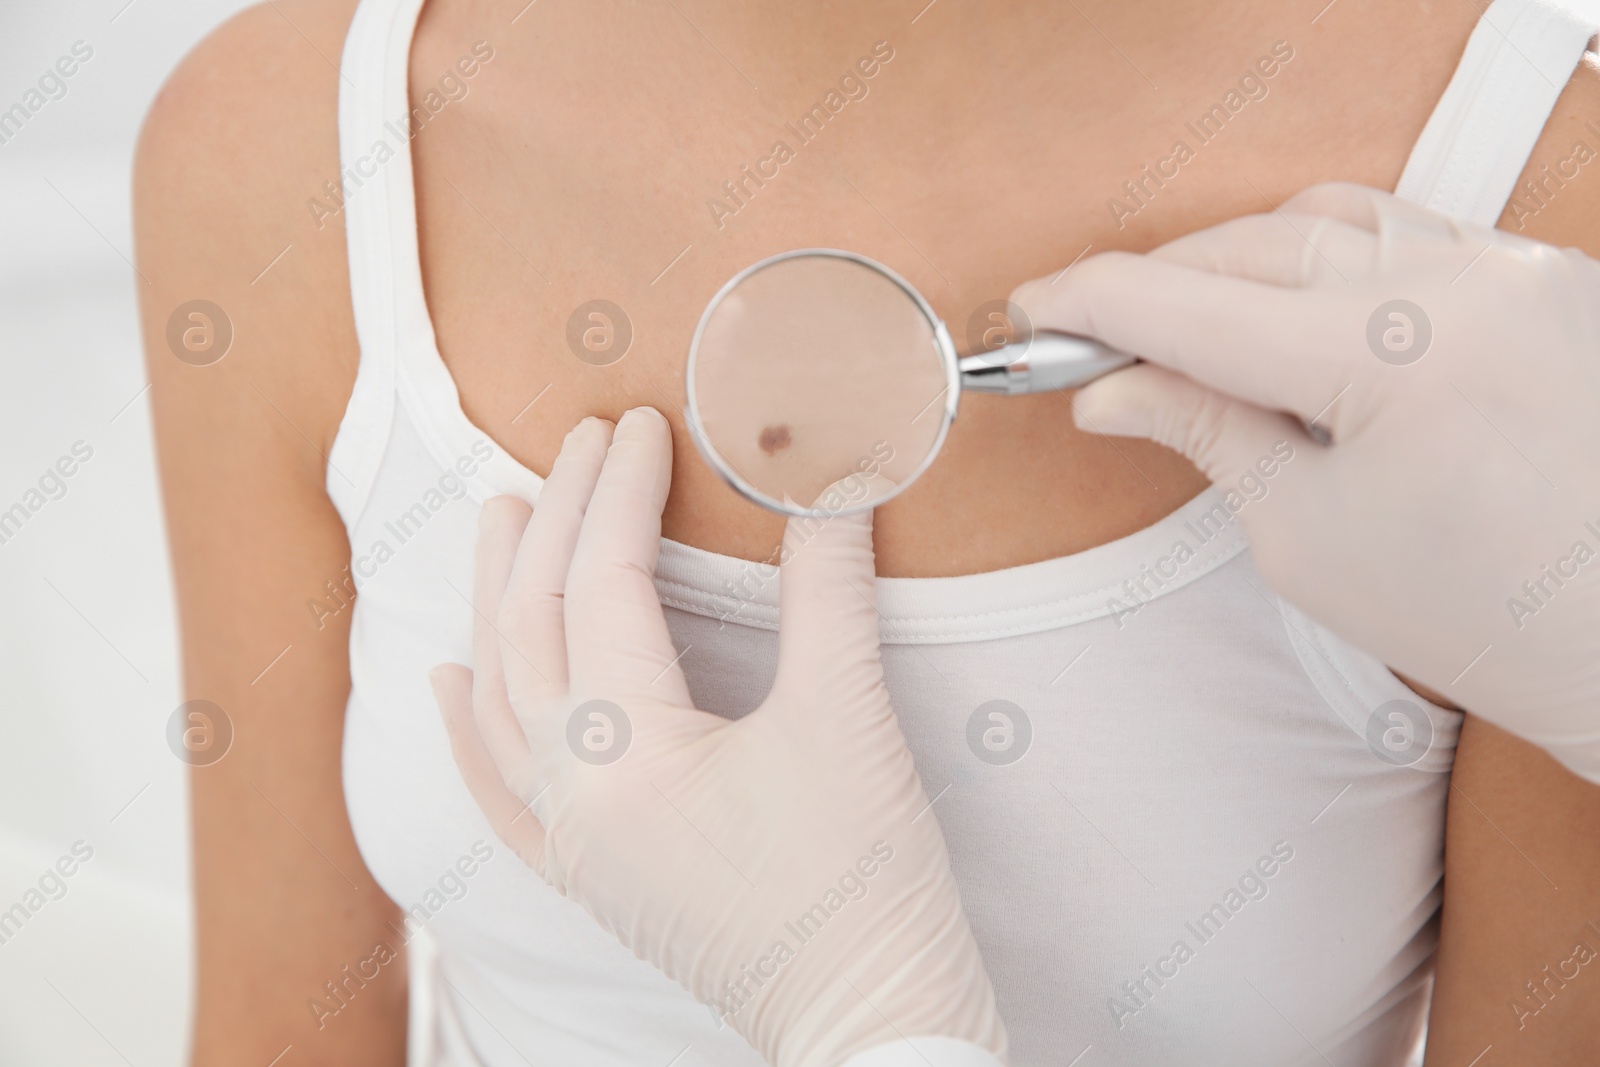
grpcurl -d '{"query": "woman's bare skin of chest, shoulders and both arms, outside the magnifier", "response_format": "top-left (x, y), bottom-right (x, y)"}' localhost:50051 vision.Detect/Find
top-left (134, 0), bottom-right (1600, 1065)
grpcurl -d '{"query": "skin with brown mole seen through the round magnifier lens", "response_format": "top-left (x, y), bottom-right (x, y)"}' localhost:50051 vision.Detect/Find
top-left (691, 254), bottom-right (946, 509)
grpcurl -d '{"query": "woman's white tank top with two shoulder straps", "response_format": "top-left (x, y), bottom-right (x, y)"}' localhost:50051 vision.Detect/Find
top-left (328, 0), bottom-right (1594, 1067)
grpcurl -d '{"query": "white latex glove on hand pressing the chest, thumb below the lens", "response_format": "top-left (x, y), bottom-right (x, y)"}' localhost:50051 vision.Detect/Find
top-left (432, 408), bottom-right (1006, 1067)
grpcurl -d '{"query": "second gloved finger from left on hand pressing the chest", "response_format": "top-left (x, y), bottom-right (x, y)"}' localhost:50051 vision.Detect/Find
top-left (472, 496), bottom-right (531, 782)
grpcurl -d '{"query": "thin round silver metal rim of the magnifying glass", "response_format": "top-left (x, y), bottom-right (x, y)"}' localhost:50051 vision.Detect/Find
top-left (683, 248), bottom-right (962, 518)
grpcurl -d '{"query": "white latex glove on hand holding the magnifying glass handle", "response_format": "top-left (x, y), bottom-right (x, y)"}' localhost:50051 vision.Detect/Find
top-left (1013, 184), bottom-right (1600, 782)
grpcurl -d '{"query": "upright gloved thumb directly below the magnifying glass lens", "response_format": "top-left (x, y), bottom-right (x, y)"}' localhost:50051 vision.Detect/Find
top-left (773, 493), bottom-right (883, 713)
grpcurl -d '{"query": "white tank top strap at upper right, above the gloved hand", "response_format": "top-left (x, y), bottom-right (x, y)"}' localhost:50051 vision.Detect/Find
top-left (1395, 0), bottom-right (1600, 226)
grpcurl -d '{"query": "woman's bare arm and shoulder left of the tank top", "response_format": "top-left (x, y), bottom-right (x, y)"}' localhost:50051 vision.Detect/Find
top-left (134, 0), bottom-right (405, 1064)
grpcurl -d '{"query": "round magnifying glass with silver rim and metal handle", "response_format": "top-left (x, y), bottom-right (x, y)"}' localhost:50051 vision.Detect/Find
top-left (685, 248), bottom-right (1138, 517)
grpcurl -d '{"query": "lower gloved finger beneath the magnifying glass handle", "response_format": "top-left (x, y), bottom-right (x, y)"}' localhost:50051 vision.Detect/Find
top-left (1072, 363), bottom-right (1315, 485)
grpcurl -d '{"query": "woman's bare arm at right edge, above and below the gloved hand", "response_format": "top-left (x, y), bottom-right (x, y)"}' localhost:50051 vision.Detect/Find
top-left (1427, 56), bottom-right (1600, 1065)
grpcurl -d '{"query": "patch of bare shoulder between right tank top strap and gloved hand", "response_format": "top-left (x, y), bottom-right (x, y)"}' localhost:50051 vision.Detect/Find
top-left (1499, 53), bottom-right (1600, 259)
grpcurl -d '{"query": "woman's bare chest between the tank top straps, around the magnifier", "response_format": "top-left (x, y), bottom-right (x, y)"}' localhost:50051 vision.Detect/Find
top-left (413, 13), bottom-right (1448, 576)
